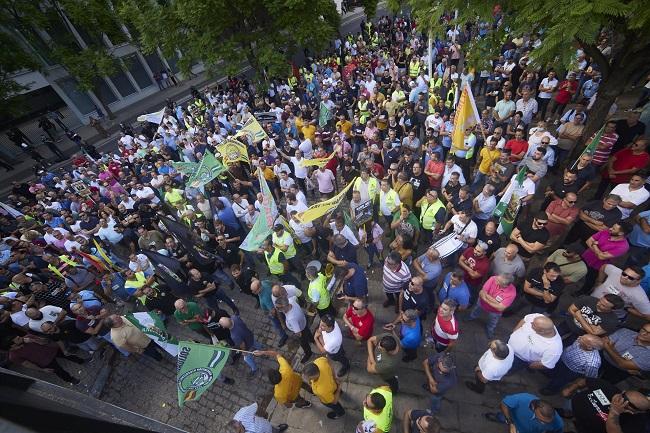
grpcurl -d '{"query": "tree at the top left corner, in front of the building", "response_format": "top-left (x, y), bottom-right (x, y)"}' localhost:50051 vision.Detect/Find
top-left (0, 0), bottom-right (133, 116)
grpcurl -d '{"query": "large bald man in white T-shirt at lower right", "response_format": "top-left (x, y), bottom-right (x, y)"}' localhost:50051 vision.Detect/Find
top-left (508, 314), bottom-right (562, 371)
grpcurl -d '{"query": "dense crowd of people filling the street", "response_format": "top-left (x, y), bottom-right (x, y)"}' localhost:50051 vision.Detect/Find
top-left (0, 11), bottom-right (650, 433)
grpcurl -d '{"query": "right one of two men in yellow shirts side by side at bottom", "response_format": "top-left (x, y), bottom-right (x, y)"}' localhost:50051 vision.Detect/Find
top-left (302, 356), bottom-right (345, 419)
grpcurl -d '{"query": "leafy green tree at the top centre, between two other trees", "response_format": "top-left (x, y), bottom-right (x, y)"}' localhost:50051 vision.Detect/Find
top-left (119, 0), bottom-right (340, 88)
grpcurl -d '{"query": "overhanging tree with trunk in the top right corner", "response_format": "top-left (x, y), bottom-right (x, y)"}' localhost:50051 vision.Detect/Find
top-left (408, 0), bottom-right (650, 137)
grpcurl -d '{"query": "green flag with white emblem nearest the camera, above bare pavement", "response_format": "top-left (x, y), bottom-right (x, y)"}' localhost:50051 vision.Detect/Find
top-left (176, 341), bottom-right (230, 407)
